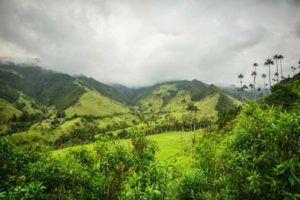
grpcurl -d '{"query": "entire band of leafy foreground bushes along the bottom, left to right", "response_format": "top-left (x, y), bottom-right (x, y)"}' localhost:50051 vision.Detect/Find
top-left (0, 105), bottom-right (300, 199)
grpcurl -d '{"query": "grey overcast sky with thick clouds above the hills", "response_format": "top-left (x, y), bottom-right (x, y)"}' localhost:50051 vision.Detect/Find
top-left (0, 0), bottom-right (300, 86)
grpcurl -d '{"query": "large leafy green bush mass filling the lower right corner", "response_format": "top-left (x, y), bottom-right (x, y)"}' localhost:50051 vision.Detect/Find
top-left (180, 105), bottom-right (300, 199)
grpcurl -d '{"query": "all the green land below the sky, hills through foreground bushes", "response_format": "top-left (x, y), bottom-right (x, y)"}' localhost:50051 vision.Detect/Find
top-left (0, 61), bottom-right (300, 199)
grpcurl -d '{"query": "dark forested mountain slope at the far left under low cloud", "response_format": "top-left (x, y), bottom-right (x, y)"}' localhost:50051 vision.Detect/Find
top-left (0, 63), bottom-right (84, 109)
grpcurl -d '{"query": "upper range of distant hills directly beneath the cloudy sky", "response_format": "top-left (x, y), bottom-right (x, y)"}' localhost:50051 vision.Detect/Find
top-left (0, 63), bottom-right (243, 120)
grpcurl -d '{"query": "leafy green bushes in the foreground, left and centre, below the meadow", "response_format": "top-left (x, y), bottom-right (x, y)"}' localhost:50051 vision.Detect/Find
top-left (0, 133), bottom-right (176, 199)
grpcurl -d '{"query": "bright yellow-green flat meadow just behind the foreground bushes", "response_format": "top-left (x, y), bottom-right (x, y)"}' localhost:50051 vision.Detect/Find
top-left (53, 130), bottom-right (202, 170)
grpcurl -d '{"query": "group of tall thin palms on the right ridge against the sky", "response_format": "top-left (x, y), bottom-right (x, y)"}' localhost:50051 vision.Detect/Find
top-left (238, 54), bottom-right (300, 102)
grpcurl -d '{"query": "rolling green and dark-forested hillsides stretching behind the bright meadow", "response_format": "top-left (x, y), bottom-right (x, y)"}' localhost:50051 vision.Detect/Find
top-left (0, 64), bottom-right (243, 149)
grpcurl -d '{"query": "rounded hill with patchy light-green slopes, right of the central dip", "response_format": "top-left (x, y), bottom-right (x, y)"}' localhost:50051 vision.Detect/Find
top-left (135, 80), bottom-right (242, 126)
